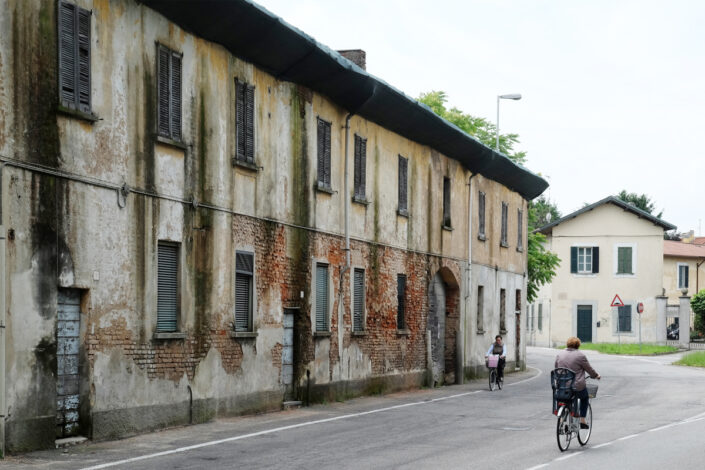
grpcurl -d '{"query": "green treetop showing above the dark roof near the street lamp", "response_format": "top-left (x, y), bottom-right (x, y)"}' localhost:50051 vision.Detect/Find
top-left (418, 91), bottom-right (526, 165)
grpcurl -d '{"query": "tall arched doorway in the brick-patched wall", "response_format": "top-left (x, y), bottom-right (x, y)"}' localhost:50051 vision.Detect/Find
top-left (428, 267), bottom-right (460, 385)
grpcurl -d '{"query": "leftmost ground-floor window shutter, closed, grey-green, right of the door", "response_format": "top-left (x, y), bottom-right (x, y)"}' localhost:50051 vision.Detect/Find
top-left (157, 243), bottom-right (179, 331)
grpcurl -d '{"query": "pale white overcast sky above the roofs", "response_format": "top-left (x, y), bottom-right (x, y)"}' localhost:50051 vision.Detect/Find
top-left (258, 0), bottom-right (705, 234)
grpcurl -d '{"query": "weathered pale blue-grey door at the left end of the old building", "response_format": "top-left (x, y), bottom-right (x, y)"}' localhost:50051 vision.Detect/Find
top-left (56, 289), bottom-right (81, 438)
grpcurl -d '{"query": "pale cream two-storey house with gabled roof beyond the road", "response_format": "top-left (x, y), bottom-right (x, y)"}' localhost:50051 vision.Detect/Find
top-left (526, 196), bottom-right (675, 346)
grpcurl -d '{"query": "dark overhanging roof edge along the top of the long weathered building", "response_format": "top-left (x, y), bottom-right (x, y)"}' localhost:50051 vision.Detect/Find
top-left (142, 0), bottom-right (548, 200)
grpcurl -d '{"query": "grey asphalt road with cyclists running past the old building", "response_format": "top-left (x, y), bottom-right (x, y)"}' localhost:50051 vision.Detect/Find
top-left (5, 348), bottom-right (705, 470)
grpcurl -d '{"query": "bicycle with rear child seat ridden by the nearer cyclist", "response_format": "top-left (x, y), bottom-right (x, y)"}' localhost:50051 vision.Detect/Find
top-left (551, 369), bottom-right (597, 452)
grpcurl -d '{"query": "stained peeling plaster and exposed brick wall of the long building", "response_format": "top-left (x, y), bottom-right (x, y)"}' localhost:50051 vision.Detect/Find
top-left (0, 0), bottom-right (526, 451)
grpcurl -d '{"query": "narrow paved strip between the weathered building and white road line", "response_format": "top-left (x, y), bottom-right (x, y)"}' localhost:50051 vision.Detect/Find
top-left (0, 369), bottom-right (538, 470)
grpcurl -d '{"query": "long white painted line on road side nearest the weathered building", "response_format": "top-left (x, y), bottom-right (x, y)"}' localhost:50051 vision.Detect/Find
top-left (82, 390), bottom-right (480, 470)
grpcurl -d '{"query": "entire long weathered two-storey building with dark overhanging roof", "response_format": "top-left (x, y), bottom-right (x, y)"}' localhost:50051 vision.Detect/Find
top-left (0, 0), bottom-right (546, 451)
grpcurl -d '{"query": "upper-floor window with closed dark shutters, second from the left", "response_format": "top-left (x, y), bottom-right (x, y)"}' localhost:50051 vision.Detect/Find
top-left (157, 44), bottom-right (182, 142)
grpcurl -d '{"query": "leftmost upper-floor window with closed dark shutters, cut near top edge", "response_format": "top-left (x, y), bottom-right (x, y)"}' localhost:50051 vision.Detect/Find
top-left (58, 1), bottom-right (91, 113)
